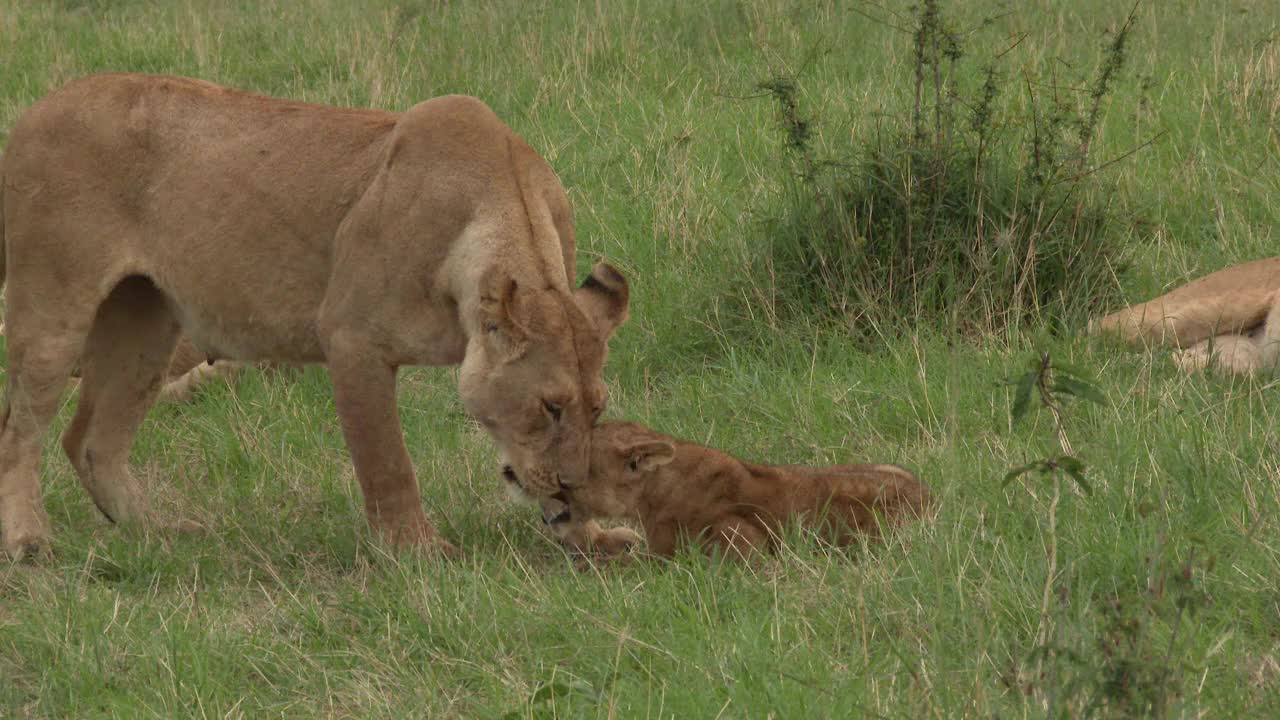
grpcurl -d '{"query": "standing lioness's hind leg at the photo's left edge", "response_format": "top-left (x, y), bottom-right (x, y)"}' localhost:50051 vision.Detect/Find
top-left (0, 325), bottom-right (83, 559)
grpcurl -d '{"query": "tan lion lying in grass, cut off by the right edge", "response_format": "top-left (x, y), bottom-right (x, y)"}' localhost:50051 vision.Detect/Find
top-left (1094, 258), bottom-right (1280, 374)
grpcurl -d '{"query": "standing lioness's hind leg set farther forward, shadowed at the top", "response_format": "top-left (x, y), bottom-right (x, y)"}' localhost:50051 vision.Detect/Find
top-left (63, 277), bottom-right (178, 521)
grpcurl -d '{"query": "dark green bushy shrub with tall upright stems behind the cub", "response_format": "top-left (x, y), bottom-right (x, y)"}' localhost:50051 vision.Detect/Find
top-left (754, 0), bottom-right (1134, 332)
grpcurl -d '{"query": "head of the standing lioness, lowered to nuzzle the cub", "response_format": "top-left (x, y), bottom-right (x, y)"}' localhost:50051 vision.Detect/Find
top-left (458, 263), bottom-right (630, 500)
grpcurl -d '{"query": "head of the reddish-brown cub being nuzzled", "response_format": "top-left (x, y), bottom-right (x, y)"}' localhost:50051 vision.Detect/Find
top-left (563, 423), bottom-right (676, 518)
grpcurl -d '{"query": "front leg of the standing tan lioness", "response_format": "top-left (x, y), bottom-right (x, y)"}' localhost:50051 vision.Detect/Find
top-left (328, 342), bottom-right (457, 555)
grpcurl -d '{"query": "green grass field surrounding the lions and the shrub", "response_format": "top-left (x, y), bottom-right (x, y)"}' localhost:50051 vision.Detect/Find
top-left (0, 0), bottom-right (1280, 719)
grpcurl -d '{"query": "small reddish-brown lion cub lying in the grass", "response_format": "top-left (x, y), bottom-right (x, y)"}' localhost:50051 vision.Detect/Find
top-left (557, 421), bottom-right (932, 557)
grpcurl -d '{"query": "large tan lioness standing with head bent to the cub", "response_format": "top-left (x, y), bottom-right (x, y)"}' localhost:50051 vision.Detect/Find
top-left (0, 74), bottom-right (628, 553)
